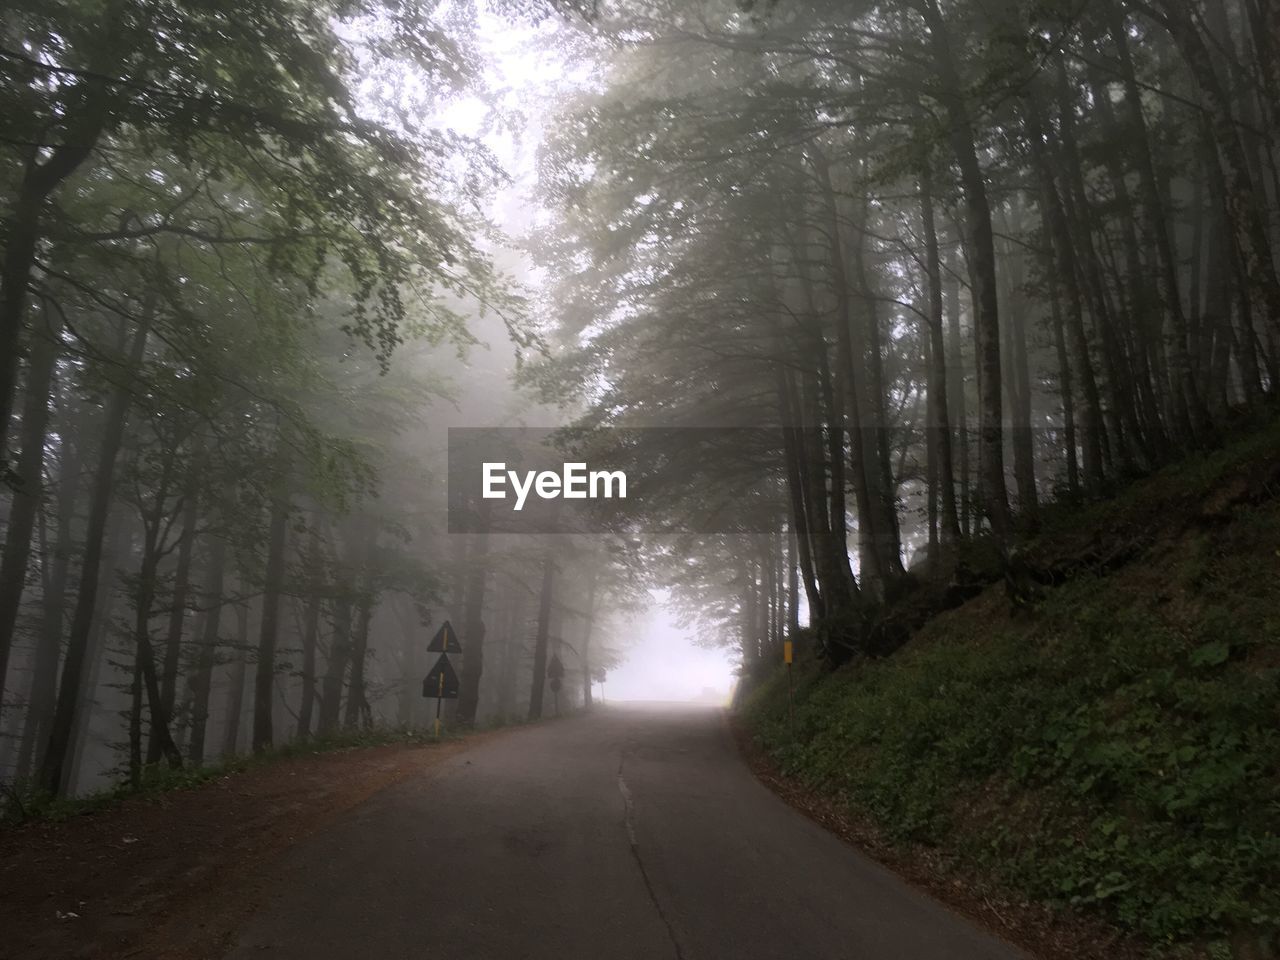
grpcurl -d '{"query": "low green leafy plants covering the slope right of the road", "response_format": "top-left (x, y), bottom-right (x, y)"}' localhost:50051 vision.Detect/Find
top-left (748, 542), bottom-right (1280, 943)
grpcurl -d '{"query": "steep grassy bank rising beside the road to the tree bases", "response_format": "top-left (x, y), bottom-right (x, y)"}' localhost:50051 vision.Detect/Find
top-left (744, 426), bottom-right (1280, 956)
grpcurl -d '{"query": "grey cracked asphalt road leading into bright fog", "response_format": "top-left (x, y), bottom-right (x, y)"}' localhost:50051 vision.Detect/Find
top-left (229, 705), bottom-right (1021, 960)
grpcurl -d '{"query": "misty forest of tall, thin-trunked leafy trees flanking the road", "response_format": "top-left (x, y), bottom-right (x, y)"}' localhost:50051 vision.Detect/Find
top-left (0, 0), bottom-right (1280, 957)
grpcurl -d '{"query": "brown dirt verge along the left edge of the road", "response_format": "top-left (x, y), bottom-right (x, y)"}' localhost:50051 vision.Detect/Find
top-left (0, 731), bottom-right (499, 960)
